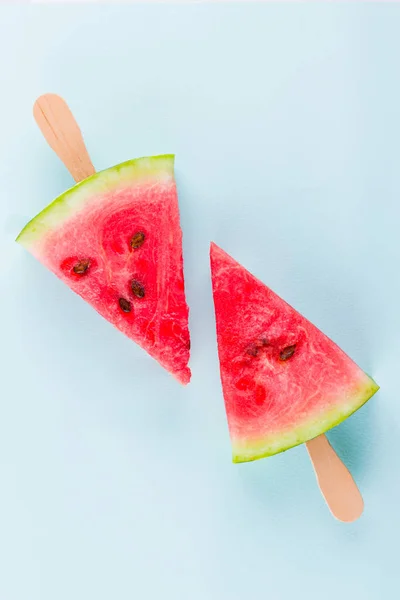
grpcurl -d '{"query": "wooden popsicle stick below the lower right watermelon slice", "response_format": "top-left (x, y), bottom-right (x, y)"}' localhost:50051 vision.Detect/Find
top-left (306, 434), bottom-right (364, 523)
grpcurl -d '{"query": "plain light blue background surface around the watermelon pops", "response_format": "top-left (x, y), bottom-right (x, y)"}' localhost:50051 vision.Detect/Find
top-left (0, 4), bottom-right (400, 600)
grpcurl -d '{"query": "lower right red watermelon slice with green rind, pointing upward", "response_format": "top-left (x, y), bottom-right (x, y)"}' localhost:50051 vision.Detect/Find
top-left (210, 244), bottom-right (379, 463)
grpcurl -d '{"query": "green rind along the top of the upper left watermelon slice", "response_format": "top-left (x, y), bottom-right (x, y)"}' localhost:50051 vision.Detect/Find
top-left (16, 154), bottom-right (175, 249)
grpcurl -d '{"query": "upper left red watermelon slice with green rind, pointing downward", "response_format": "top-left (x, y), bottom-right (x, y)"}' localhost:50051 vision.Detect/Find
top-left (17, 155), bottom-right (190, 384)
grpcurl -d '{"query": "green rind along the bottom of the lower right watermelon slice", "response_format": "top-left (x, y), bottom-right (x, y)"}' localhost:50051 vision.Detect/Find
top-left (232, 375), bottom-right (379, 463)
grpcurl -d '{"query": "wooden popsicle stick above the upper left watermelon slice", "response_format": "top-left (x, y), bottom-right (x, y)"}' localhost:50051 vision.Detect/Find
top-left (33, 94), bottom-right (95, 182)
